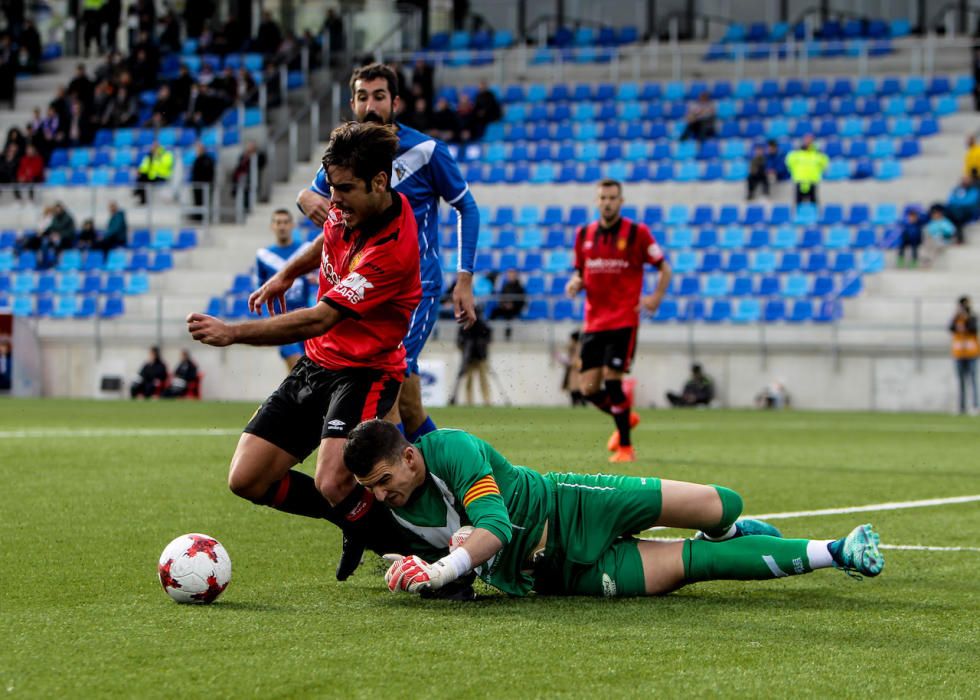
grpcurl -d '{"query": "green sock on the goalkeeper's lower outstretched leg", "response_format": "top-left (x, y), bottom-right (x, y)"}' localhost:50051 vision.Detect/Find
top-left (683, 535), bottom-right (816, 583)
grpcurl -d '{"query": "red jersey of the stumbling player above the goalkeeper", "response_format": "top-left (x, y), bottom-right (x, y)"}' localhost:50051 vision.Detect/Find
top-left (306, 193), bottom-right (422, 372)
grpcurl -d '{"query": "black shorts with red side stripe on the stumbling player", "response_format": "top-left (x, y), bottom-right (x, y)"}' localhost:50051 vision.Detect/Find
top-left (244, 356), bottom-right (402, 462)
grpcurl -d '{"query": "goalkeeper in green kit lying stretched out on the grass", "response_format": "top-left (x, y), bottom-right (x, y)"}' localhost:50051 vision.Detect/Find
top-left (344, 420), bottom-right (884, 596)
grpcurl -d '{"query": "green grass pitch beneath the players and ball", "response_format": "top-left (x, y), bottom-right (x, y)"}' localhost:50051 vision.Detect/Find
top-left (0, 400), bottom-right (980, 699)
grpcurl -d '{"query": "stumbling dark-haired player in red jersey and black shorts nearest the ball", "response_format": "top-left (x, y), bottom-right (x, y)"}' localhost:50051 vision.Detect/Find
top-left (187, 122), bottom-right (422, 580)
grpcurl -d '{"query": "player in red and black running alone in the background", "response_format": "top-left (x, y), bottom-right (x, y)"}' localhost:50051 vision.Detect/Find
top-left (565, 180), bottom-right (671, 462)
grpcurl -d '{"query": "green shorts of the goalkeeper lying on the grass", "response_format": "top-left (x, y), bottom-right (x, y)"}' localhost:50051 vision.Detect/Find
top-left (535, 473), bottom-right (663, 596)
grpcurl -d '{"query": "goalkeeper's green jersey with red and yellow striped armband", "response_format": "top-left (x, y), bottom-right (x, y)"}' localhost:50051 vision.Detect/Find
top-left (392, 430), bottom-right (554, 595)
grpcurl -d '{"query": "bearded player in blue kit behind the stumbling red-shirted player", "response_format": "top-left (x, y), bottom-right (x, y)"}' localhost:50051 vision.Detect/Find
top-left (296, 63), bottom-right (480, 442)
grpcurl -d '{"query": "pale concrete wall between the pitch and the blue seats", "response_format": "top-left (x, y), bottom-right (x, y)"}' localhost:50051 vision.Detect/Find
top-left (32, 333), bottom-right (957, 412)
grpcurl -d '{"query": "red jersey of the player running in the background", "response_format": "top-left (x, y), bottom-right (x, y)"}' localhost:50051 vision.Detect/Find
top-left (575, 218), bottom-right (664, 333)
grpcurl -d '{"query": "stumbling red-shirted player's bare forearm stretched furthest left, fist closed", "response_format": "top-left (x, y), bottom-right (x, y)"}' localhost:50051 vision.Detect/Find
top-left (187, 302), bottom-right (344, 348)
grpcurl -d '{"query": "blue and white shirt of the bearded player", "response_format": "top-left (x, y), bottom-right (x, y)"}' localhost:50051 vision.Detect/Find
top-left (310, 124), bottom-right (477, 297)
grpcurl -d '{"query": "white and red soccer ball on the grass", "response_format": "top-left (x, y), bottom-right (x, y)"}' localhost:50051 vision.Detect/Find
top-left (157, 533), bottom-right (231, 603)
